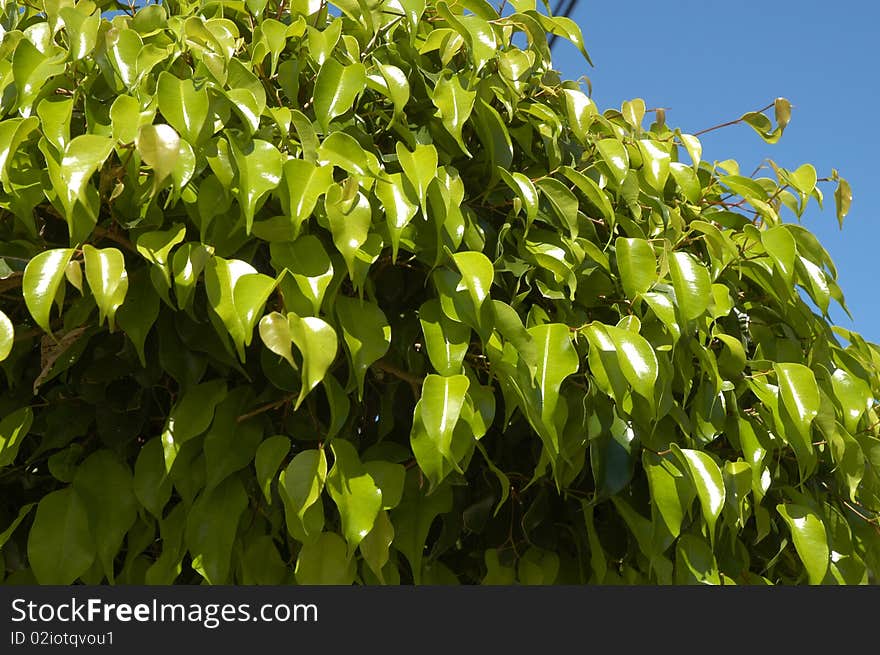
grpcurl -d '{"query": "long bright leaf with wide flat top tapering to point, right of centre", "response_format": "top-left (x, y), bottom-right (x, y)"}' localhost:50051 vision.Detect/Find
top-left (527, 323), bottom-right (578, 452)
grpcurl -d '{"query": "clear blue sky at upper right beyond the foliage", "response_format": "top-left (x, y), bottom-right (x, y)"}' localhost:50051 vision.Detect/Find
top-left (551, 0), bottom-right (880, 343)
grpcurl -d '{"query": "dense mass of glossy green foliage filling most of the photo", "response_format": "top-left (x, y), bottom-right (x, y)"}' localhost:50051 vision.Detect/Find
top-left (0, 0), bottom-right (880, 584)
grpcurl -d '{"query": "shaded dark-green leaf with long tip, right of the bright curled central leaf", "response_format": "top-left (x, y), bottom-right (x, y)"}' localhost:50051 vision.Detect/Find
top-left (335, 296), bottom-right (391, 400)
